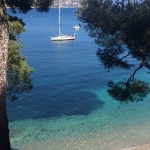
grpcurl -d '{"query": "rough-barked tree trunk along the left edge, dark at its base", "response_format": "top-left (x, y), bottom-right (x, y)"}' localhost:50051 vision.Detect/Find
top-left (0, 2), bottom-right (11, 150)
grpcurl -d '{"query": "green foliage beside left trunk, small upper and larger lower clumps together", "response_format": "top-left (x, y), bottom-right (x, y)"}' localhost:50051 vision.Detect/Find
top-left (7, 16), bottom-right (33, 100)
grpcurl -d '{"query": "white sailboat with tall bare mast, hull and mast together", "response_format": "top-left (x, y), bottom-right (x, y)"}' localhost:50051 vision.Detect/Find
top-left (50, 0), bottom-right (75, 41)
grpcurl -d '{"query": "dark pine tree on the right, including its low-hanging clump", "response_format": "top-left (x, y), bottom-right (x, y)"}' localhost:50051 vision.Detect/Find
top-left (78, 0), bottom-right (150, 101)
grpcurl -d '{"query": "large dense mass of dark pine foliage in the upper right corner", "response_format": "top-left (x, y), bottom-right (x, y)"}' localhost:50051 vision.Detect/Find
top-left (78, 0), bottom-right (150, 61)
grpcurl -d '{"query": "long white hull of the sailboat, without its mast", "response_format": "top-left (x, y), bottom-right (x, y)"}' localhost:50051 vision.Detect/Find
top-left (51, 35), bottom-right (75, 41)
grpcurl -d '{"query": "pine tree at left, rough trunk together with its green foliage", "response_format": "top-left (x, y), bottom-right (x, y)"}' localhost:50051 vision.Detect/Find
top-left (0, 0), bottom-right (52, 150)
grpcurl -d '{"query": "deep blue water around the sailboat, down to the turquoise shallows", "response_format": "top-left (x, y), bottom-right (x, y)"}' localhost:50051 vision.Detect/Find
top-left (7, 9), bottom-right (109, 120)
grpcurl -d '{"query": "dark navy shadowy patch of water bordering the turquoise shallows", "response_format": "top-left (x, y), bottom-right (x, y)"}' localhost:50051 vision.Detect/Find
top-left (9, 92), bottom-right (104, 121)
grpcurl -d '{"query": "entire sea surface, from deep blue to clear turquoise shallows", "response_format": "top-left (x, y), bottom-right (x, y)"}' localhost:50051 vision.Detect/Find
top-left (8, 9), bottom-right (150, 150)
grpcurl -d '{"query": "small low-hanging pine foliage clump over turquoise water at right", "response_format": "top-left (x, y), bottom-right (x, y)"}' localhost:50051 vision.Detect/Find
top-left (108, 80), bottom-right (150, 102)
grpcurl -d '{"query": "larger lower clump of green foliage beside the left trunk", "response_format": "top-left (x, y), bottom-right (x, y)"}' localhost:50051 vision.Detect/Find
top-left (7, 40), bottom-right (33, 100)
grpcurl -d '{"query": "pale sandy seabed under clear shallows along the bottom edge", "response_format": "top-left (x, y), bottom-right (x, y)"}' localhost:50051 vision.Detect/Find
top-left (13, 121), bottom-right (150, 150)
